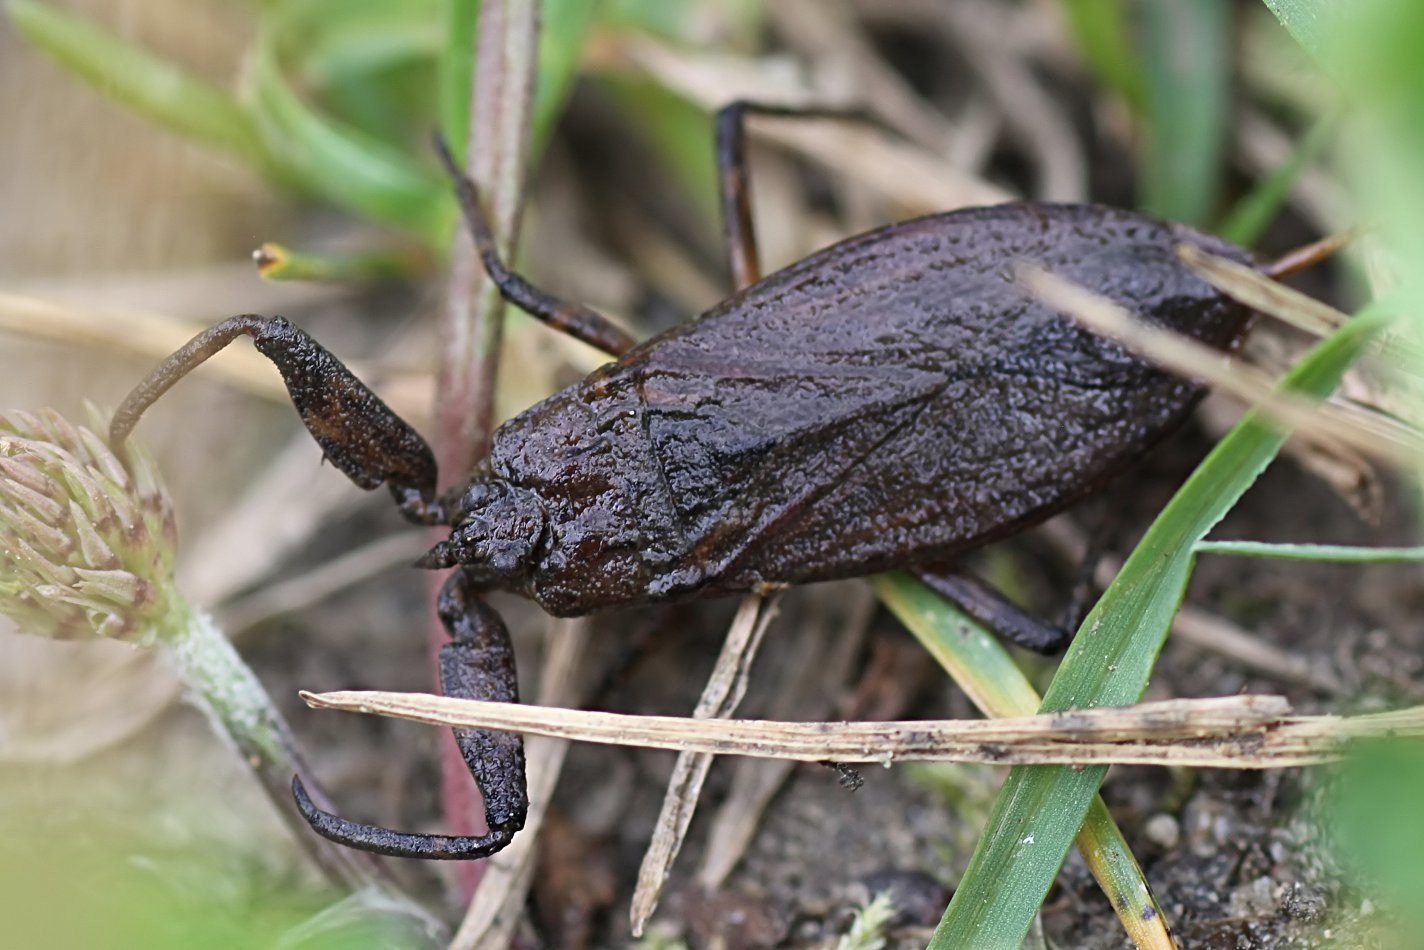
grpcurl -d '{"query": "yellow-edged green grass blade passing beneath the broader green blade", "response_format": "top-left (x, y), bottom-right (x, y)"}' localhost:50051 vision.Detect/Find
top-left (870, 573), bottom-right (1172, 947)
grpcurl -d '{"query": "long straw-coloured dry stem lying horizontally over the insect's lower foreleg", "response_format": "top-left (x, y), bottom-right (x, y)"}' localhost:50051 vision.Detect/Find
top-left (302, 691), bottom-right (1424, 769)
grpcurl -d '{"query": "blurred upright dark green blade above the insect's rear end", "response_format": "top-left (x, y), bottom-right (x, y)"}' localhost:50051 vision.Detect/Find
top-left (1139, 0), bottom-right (1232, 225)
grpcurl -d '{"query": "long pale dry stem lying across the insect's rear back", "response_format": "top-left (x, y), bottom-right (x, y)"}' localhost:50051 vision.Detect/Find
top-left (1018, 263), bottom-right (1424, 466)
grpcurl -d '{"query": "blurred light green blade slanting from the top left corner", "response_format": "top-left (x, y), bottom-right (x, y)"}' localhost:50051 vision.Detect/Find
top-left (6, 0), bottom-right (266, 167)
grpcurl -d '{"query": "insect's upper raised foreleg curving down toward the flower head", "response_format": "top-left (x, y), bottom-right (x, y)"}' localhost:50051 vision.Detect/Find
top-left (108, 313), bottom-right (444, 524)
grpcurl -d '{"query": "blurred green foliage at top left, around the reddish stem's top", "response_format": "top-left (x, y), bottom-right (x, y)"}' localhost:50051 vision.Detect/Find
top-left (7, 0), bottom-right (597, 248)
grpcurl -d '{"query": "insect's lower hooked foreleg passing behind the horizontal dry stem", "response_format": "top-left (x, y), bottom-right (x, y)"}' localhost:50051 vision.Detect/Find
top-left (292, 570), bottom-right (528, 859)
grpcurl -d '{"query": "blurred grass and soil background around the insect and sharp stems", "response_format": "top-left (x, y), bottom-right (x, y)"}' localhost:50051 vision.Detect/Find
top-left (0, 0), bottom-right (1424, 947)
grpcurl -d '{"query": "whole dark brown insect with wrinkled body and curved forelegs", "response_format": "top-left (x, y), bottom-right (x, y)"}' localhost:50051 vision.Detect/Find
top-left (111, 104), bottom-right (1249, 857)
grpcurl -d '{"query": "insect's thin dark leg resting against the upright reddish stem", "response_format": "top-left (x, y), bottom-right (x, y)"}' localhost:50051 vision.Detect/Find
top-left (436, 137), bottom-right (635, 356)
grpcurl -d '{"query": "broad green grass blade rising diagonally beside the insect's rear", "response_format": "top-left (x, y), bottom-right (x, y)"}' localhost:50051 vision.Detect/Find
top-left (930, 312), bottom-right (1388, 950)
